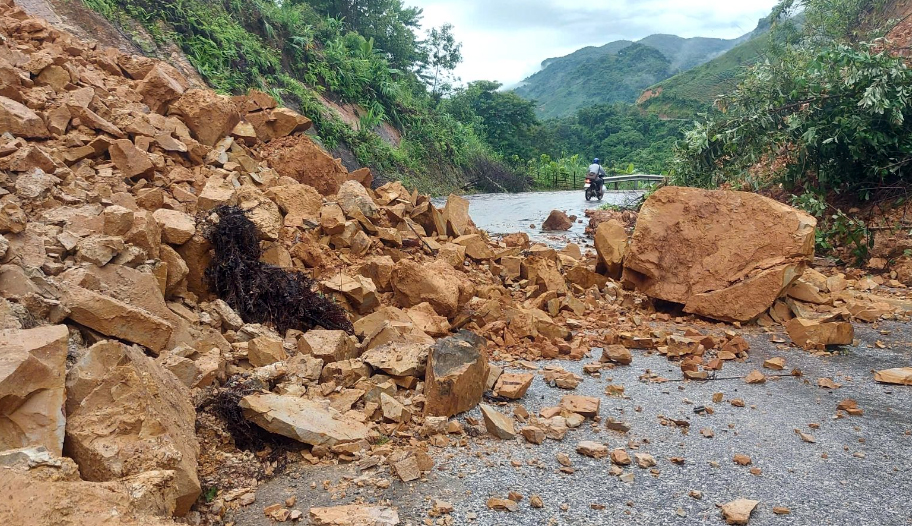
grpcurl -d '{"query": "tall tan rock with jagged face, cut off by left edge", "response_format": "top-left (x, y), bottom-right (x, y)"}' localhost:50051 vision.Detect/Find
top-left (0, 325), bottom-right (69, 456)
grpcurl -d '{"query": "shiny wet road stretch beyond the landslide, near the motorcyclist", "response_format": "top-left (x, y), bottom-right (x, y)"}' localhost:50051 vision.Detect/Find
top-left (433, 189), bottom-right (643, 245)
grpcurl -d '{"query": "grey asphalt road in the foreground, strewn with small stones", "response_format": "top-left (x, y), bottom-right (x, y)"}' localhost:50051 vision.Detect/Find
top-left (226, 323), bottom-right (912, 526)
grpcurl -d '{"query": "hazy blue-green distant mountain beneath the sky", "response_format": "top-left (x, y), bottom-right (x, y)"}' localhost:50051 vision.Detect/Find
top-left (516, 34), bottom-right (751, 118)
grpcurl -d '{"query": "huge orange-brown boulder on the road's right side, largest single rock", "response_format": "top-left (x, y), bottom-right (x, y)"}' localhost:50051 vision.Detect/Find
top-left (623, 187), bottom-right (817, 322)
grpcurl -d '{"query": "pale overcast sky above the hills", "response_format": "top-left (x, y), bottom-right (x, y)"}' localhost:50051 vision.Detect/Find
top-left (412, 0), bottom-right (776, 86)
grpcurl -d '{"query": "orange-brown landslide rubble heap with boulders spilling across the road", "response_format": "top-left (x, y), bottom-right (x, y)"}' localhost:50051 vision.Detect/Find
top-left (0, 0), bottom-right (912, 525)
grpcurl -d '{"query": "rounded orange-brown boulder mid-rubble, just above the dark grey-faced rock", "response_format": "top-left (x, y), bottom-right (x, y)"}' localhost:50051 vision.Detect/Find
top-left (390, 259), bottom-right (475, 318)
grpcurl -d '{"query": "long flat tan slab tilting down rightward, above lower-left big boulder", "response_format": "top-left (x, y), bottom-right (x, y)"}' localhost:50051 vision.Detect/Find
top-left (63, 286), bottom-right (174, 354)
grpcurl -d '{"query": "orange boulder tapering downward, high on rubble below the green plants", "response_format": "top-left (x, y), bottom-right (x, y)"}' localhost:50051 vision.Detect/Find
top-left (169, 89), bottom-right (241, 147)
